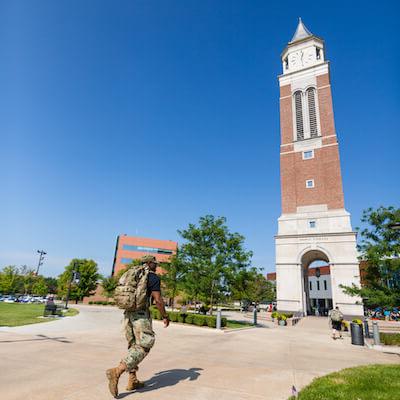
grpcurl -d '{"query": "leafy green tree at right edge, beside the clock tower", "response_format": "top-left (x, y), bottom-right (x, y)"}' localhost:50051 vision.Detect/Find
top-left (341, 207), bottom-right (400, 307)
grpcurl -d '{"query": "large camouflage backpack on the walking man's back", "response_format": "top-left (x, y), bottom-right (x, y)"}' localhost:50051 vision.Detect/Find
top-left (114, 265), bottom-right (149, 311)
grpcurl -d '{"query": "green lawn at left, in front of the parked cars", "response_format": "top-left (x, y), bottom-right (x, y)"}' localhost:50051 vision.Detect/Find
top-left (0, 302), bottom-right (79, 326)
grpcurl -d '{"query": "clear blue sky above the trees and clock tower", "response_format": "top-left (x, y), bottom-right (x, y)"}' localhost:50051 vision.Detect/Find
top-left (0, 0), bottom-right (400, 275)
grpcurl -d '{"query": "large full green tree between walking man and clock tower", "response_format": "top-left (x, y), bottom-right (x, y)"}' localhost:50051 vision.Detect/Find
top-left (178, 215), bottom-right (252, 313)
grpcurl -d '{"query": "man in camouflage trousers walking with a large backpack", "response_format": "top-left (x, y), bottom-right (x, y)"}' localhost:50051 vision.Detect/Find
top-left (106, 255), bottom-right (169, 398)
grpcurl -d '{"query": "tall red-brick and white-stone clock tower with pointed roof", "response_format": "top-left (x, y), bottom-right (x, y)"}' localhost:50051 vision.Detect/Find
top-left (275, 19), bottom-right (363, 315)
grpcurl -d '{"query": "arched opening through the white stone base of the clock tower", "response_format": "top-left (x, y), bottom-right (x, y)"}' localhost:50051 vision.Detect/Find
top-left (301, 249), bottom-right (332, 315)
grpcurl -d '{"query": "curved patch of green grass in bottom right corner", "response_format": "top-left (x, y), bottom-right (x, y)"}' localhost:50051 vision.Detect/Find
top-left (290, 364), bottom-right (400, 400)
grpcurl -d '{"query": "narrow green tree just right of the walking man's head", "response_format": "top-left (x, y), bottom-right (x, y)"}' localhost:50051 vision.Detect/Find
top-left (160, 251), bottom-right (186, 310)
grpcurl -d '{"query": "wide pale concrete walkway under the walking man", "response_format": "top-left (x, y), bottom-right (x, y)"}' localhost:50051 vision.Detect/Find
top-left (0, 306), bottom-right (400, 400)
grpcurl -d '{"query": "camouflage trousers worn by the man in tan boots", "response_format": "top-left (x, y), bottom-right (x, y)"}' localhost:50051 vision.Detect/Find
top-left (122, 311), bottom-right (155, 371)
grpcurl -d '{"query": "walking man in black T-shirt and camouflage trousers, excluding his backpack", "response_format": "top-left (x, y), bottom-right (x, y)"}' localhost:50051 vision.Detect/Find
top-left (106, 255), bottom-right (169, 398)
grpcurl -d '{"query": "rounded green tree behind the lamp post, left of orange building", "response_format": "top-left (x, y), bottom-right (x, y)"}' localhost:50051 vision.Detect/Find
top-left (58, 258), bottom-right (101, 301)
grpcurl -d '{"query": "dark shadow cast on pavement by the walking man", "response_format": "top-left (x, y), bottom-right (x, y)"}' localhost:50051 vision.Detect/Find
top-left (118, 368), bottom-right (203, 399)
